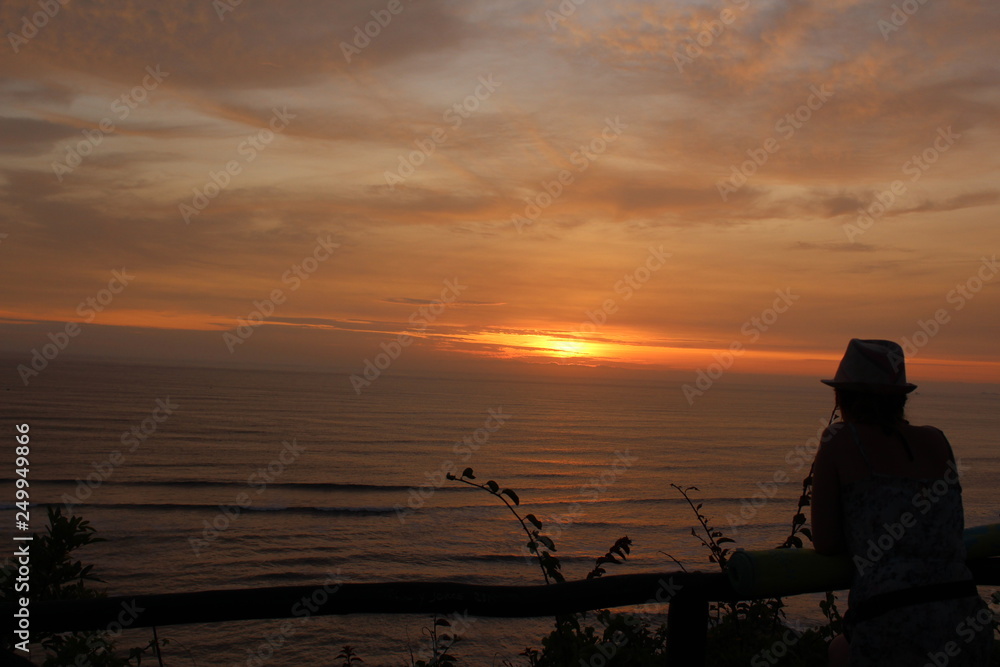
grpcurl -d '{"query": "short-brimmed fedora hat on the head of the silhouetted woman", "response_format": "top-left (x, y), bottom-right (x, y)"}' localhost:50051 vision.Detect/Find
top-left (820, 338), bottom-right (917, 394)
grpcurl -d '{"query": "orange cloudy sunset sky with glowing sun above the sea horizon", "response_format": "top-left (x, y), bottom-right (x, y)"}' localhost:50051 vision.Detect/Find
top-left (0, 0), bottom-right (1000, 384)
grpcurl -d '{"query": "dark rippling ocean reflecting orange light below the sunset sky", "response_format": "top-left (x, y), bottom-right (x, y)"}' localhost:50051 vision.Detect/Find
top-left (0, 359), bottom-right (1000, 666)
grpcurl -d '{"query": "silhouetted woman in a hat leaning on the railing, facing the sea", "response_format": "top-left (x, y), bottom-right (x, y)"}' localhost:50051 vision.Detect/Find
top-left (812, 339), bottom-right (993, 667)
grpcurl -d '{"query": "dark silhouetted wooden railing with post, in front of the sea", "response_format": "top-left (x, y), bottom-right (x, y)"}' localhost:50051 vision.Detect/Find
top-left (9, 549), bottom-right (1000, 666)
